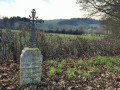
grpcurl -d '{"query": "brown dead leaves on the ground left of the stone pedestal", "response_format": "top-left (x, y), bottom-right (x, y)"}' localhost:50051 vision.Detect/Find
top-left (0, 60), bottom-right (19, 90)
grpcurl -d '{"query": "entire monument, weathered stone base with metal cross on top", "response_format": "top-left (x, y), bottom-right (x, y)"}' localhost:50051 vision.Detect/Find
top-left (20, 9), bottom-right (43, 90)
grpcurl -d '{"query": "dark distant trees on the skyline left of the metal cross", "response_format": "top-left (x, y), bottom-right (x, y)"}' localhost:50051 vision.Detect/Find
top-left (0, 16), bottom-right (42, 30)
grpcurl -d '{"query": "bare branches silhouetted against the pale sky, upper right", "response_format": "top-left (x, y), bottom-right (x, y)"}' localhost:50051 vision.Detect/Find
top-left (77, 0), bottom-right (120, 20)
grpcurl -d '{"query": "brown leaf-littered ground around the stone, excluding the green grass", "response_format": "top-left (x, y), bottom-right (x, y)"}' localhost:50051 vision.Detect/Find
top-left (0, 58), bottom-right (120, 90)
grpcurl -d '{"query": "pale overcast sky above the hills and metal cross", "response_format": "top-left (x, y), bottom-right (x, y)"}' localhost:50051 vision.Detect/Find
top-left (0, 0), bottom-right (85, 20)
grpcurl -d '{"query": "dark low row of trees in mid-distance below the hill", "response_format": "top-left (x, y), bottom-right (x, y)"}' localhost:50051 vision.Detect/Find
top-left (45, 29), bottom-right (84, 35)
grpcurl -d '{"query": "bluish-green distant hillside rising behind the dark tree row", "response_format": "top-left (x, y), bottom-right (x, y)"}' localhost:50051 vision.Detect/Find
top-left (38, 18), bottom-right (100, 30)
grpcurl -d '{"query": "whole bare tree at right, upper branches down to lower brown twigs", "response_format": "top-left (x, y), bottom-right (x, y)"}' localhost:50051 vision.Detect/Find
top-left (77, 0), bottom-right (120, 37)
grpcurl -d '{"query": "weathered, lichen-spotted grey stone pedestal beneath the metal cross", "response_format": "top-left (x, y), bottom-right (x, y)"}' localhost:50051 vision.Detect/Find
top-left (20, 48), bottom-right (43, 85)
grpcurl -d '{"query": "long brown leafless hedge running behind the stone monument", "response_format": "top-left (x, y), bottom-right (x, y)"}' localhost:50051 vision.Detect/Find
top-left (0, 31), bottom-right (120, 61)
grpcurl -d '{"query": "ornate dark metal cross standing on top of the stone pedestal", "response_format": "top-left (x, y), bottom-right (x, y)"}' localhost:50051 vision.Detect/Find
top-left (29, 9), bottom-right (44, 48)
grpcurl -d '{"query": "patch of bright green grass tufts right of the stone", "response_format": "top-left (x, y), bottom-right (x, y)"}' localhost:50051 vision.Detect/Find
top-left (48, 56), bottom-right (120, 79)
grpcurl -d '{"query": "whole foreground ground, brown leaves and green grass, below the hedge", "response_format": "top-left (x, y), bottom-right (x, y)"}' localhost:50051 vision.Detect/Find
top-left (0, 56), bottom-right (120, 90)
